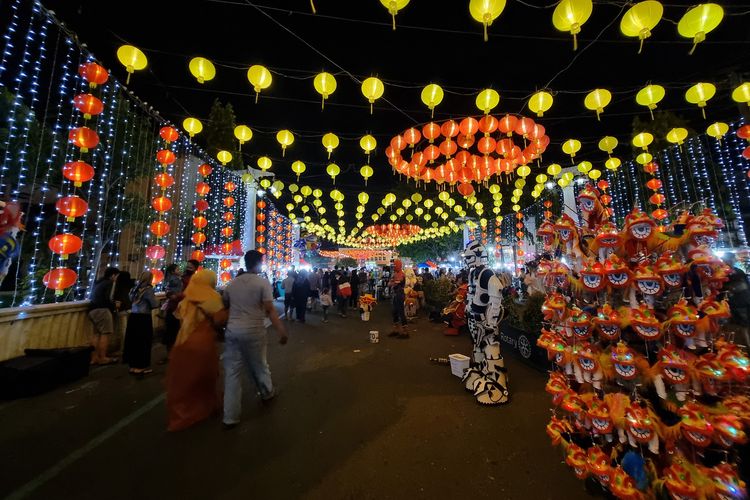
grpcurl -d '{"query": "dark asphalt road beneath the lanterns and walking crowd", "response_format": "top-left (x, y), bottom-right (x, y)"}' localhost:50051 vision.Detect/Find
top-left (0, 303), bottom-right (586, 500)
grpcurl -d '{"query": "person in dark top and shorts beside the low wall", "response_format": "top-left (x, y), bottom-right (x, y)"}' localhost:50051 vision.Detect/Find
top-left (88, 267), bottom-right (120, 365)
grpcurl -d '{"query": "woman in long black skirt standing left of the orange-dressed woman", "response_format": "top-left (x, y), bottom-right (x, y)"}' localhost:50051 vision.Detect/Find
top-left (122, 271), bottom-right (159, 375)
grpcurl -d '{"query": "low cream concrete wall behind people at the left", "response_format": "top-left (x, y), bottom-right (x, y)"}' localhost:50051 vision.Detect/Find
top-left (0, 294), bottom-right (163, 361)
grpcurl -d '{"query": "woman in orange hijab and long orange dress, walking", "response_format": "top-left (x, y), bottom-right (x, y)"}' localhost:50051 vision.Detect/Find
top-left (167, 269), bottom-right (227, 431)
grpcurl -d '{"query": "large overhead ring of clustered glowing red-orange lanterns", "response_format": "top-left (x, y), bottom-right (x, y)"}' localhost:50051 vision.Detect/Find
top-left (385, 114), bottom-right (550, 191)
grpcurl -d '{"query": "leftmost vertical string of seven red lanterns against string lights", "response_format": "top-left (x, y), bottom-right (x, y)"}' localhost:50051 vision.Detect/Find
top-left (42, 62), bottom-right (109, 295)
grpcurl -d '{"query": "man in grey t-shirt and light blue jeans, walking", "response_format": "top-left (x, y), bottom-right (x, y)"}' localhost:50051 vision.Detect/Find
top-left (222, 250), bottom-right (287, 429)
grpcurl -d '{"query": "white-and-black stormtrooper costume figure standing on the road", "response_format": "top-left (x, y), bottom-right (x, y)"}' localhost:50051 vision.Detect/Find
top-left (462, 240), bottom-right (510, 405)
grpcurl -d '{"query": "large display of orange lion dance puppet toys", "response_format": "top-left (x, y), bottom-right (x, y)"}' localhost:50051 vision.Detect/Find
top-left (536, 186), bottom-right (750, 499)
